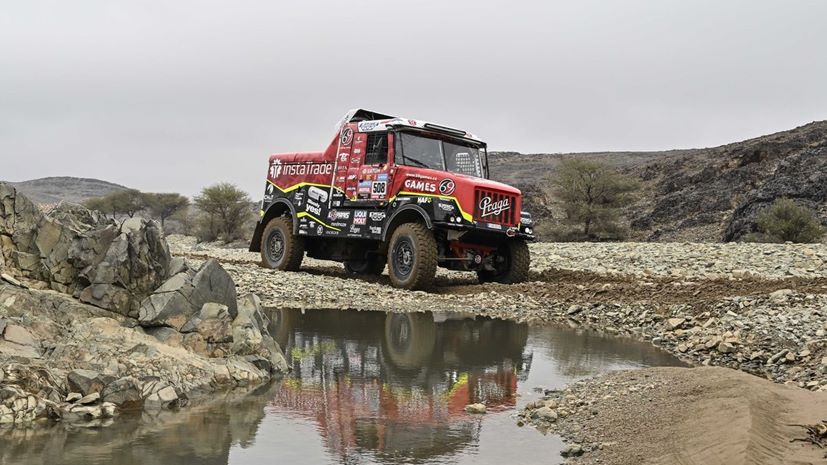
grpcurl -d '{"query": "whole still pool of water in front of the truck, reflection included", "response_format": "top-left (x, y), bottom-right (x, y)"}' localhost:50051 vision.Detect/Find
top-left (0, 311), bottom-right (680, 465)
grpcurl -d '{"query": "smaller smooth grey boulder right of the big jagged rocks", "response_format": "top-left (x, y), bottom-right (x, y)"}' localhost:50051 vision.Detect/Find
top-left (138, 260), bottom-right (238, 331)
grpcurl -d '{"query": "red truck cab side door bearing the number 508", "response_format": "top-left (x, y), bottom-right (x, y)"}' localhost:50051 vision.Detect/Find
top-left (345, 132), bottom-right (393, 201)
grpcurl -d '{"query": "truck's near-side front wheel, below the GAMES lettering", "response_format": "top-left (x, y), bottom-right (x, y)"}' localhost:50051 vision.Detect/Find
top-left (388, 223), bottom-right (437, 289)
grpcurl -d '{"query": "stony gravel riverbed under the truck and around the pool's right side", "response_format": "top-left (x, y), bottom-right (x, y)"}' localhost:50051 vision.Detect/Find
top-left (170, 236), bottom-right (827, 463)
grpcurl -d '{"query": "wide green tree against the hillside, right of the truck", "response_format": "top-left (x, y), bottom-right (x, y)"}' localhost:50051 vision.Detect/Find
top-left (552, 158), bottom-right (638, 239)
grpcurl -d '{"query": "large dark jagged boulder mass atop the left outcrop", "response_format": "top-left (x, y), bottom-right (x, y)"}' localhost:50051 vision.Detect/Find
top-left (0, 183), bottom-right (171, 316)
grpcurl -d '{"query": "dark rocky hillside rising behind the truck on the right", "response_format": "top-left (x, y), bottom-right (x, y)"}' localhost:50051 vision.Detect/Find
top-left (491, 121), bottom-right (827, 242)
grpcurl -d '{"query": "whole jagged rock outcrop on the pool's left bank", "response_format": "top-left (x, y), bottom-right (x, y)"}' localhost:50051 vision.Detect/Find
top-left (0, 183), bottom-right (287, 426)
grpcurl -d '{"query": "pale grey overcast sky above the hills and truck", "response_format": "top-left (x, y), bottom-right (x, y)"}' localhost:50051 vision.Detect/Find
top-left (0, 0), bottom-right (827, 198)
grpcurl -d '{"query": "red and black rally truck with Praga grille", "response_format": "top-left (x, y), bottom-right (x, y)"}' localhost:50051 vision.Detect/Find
top-left (250, 109), bottom-right (534, 289)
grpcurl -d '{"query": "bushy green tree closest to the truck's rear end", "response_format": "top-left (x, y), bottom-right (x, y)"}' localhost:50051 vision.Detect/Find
top-left (195, 182), bottom-right (251, 241)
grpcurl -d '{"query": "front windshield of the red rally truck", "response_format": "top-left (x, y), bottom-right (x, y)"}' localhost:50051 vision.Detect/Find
top-left (397, 133), bottom-right (483, 177)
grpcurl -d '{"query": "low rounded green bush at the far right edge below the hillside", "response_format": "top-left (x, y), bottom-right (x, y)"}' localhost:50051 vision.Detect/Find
top-left (745, 199), bottom-right (824, 243)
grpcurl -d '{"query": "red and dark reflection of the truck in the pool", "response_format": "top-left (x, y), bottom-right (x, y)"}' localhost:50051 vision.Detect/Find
top-left (268, 310), bottom-right (531, 463)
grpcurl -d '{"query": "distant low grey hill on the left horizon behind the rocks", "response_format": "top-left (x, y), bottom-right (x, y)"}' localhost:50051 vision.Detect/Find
top-left (3, 176), bottom-right (128, 204)
